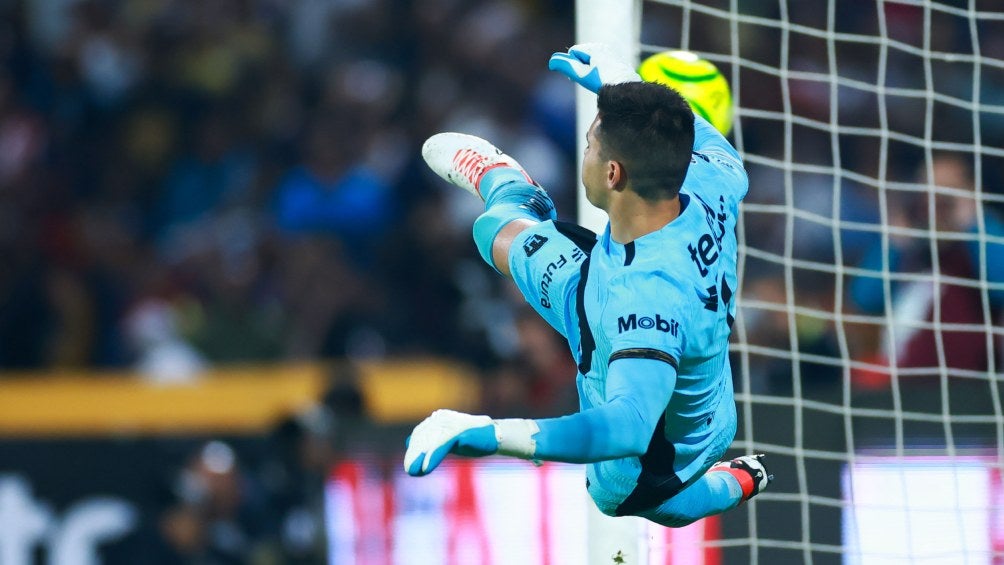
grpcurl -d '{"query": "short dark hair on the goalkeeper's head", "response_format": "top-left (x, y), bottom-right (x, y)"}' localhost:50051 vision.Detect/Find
top-left (596, 82), bottom-right (694, 200)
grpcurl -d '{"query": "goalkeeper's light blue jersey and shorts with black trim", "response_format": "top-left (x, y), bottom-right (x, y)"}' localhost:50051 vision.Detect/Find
top-left (510, 117), bottom-right (748, 515)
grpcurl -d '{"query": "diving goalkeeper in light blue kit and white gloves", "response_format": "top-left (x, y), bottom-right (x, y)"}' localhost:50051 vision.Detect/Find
top-left (405, 44), bottom-right (772, 527)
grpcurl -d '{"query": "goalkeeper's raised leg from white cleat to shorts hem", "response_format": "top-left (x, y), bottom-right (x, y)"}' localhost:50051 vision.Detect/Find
top-left (422, 132), bottom-right (556, 276)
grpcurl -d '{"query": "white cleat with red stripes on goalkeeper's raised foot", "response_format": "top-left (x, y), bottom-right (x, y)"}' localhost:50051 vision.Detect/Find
top-left (422, 131), bottom-right (535, 200)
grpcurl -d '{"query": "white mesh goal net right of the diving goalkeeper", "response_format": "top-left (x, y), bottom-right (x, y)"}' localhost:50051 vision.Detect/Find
top-left (576, 0), bottom-right (1004, 563)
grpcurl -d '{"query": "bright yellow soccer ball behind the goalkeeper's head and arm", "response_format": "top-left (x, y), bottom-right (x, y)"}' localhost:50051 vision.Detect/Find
top-left (638, 50), bottom-right (732, 135)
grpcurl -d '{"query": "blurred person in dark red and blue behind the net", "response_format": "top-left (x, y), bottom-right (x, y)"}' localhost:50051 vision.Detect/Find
top-left (850, 153), bottom-right (1004, 375)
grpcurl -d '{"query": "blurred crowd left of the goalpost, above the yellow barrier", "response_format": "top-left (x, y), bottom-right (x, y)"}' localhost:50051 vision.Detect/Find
top-left (0, 0), bottom-right (574, 389)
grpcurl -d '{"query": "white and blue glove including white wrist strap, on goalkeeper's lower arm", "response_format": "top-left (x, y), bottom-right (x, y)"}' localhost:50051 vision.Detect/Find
top-left (405, 409), bottom-right (539, 477)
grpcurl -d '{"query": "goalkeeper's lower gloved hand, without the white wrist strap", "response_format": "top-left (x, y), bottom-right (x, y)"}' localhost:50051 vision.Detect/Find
top-left (405, 409), bottom-right (499, 477)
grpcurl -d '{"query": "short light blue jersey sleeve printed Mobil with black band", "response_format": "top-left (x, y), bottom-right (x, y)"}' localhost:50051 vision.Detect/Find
top-left (601, 272), bottom-right (696, 368)
